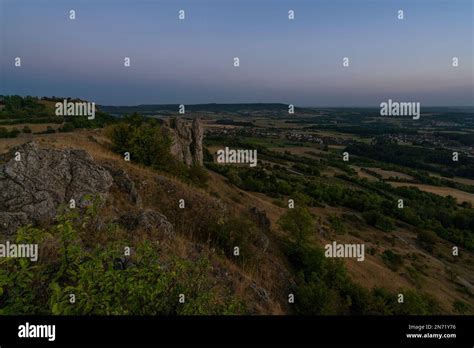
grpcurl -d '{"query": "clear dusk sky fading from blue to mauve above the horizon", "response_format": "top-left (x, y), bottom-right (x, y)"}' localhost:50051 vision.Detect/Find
top-left (0, 0), bottom-right (474, 107)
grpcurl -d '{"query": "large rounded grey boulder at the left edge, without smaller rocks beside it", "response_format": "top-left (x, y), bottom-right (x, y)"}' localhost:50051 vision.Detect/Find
top-left (0, 142), bottom-right (113, 234)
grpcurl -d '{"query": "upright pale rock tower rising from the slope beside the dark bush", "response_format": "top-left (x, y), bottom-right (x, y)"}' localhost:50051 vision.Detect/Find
top-left (166, 117), bottom-right (204, 166)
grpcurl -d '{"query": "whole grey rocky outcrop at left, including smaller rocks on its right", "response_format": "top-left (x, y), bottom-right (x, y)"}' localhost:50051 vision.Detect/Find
top-left (0, 142), bottom-right (175, 238)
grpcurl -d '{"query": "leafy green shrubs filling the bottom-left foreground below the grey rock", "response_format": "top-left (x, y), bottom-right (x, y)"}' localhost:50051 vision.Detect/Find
top-left (0, 207), bottom-right (245, 315)
